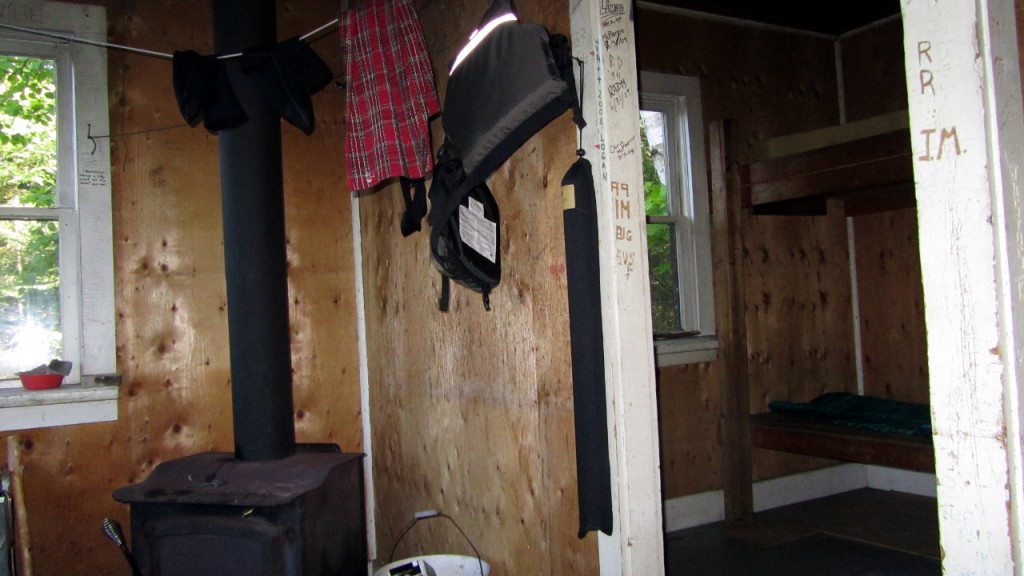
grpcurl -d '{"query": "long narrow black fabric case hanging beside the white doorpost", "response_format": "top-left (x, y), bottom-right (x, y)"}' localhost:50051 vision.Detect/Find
top-left (562, 56), bottom-right (614, 538)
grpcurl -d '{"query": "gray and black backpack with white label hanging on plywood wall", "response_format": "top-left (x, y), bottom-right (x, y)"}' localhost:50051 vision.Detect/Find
top-left (428, 0), bottom-right (582, 311)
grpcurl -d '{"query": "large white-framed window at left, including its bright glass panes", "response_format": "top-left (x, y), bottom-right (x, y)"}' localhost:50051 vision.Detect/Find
top-left (0, 0), bottom-right (117, 429)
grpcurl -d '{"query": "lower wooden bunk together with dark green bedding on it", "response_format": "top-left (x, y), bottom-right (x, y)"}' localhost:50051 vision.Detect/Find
top-left (750, 393), bottom-right (935, 472)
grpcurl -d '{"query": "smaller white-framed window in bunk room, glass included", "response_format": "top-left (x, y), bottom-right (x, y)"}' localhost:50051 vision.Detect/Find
top-left (640, 72), bottom-right (718, 366)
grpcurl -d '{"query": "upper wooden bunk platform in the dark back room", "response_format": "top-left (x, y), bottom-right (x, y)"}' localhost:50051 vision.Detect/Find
top-left (740, 113), bottom-right (914, 215)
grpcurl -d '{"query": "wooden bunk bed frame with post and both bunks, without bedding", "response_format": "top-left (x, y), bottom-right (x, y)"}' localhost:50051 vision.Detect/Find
top-left (709, 113), bottom-right (934, 521)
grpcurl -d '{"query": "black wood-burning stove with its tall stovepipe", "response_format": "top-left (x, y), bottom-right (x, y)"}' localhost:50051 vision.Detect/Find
top-left (114, 0), bottom-right (368, 576)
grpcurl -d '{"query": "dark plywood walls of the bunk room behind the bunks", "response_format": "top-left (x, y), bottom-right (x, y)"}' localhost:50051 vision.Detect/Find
top-left (637, 9), bottom-right (927, 500)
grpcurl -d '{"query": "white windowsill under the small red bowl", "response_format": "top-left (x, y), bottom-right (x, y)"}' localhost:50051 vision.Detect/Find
top-left (0, 376), bottom-right (121, 431)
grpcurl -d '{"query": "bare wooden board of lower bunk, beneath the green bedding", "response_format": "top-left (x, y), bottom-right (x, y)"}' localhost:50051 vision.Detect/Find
top-left (750, 412), bottom-right (935, 472)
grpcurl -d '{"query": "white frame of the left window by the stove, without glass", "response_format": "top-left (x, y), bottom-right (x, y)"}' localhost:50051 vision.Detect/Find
top-left (0, 1), bottom-right (119, 431)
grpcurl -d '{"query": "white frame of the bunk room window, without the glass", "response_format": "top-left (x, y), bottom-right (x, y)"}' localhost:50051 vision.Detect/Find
top-left (639, 72), bottom-right (718, 366)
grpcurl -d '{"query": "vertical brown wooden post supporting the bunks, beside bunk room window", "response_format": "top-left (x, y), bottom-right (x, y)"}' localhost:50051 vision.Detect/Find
top-left (709, 120), bottom-right (754, 524)
